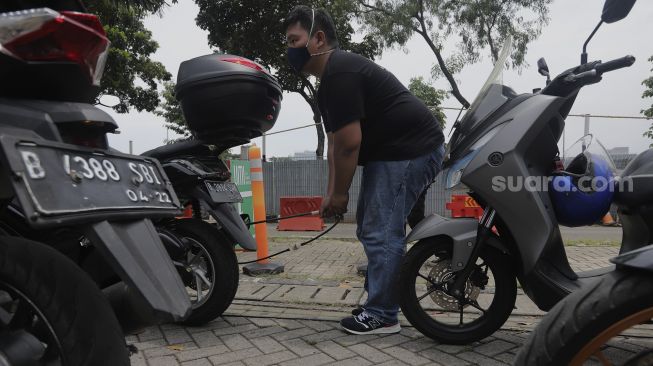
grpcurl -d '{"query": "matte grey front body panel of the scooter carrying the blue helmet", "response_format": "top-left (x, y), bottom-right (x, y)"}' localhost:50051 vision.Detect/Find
top-left (461, 95), bottom-right (566, 273)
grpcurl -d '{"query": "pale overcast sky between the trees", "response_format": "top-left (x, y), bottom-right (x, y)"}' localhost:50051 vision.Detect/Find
top-left (104, 0), bottom-right (653, 157)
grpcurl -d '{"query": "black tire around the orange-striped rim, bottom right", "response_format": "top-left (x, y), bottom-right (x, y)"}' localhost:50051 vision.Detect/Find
top-left (515, 270), bottom-right (653, 365)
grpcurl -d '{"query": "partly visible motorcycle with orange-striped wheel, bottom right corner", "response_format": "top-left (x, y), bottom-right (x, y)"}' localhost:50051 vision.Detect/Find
top-left (515, 243), bottom-right (653, 366)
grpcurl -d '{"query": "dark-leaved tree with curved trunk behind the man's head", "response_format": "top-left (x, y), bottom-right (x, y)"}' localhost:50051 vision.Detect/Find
top-left (195, 0), bottom-right (380, 159)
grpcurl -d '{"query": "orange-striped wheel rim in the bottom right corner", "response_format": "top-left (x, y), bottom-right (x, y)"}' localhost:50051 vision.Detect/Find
top-left (570, 307), bottom-right (653, 366)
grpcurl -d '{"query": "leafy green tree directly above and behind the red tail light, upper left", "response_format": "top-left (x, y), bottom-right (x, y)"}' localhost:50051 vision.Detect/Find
top-left (87, 0), bottom-right (171, 113)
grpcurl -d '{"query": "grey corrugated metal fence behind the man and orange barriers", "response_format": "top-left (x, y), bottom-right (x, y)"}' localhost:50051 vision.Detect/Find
top-left (263, 154), bottom-right (635, 222)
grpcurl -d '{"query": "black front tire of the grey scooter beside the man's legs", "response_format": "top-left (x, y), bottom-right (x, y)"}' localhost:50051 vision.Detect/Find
top-left (400, 237), bottom-right (517, 344)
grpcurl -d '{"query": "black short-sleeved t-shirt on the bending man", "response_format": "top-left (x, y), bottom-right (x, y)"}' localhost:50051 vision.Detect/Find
top-left (318, 50), bottom-right (444, 165)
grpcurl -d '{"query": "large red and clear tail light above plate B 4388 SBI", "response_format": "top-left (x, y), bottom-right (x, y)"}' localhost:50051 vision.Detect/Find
top-left (0, 8), bottom-right (111, 85)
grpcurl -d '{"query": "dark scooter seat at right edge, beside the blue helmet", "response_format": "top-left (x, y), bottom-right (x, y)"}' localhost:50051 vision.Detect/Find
top-left (614, 149), bottom-right (653, 207)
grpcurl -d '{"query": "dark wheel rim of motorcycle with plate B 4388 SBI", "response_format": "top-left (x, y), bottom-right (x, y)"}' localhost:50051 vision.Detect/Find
top-left (0, 280), bottom-right (67, 366)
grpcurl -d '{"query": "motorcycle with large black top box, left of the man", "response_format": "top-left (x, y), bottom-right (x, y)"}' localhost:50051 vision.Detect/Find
top-left (142, 54), bottom-right (282, 325)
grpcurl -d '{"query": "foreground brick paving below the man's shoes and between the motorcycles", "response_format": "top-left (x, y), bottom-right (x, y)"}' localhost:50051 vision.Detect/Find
top-left (127, 314), bottom-right (653, 366)
